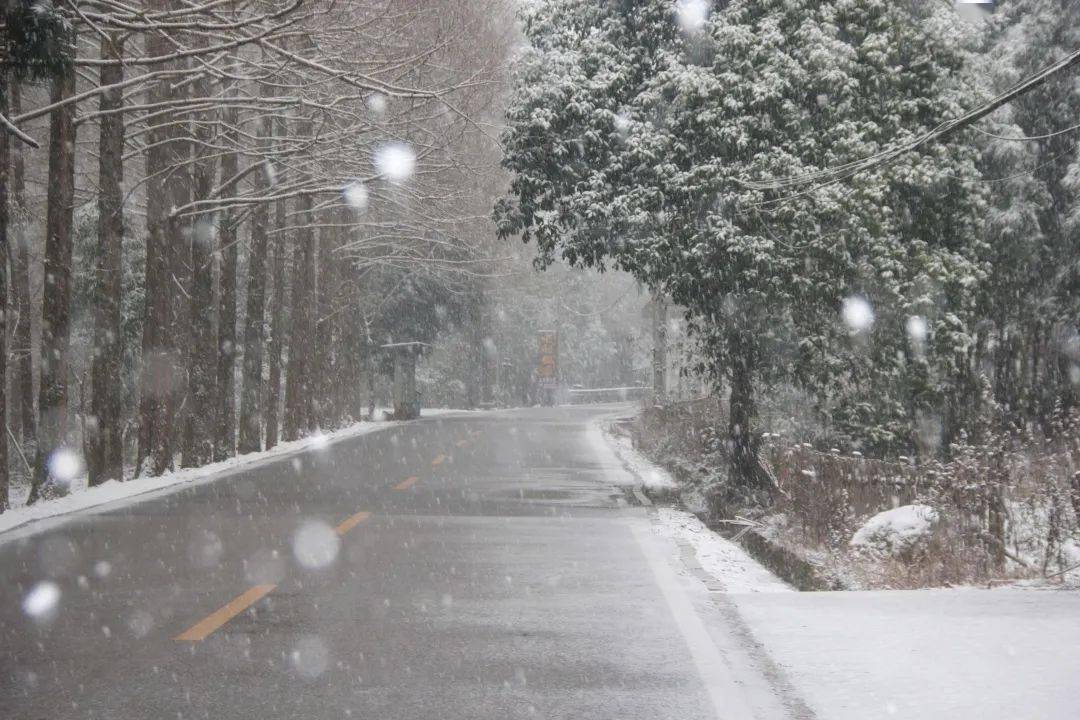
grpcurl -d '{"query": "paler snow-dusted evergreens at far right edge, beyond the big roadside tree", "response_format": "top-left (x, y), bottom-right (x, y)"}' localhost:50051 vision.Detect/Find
top-left (982, 0), bottom-right (1080, 427)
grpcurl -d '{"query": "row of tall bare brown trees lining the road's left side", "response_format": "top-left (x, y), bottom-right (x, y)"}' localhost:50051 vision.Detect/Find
top-left (0, 0), bottom-right (513, 507)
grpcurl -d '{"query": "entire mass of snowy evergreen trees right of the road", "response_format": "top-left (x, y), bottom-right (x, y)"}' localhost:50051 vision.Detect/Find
top-left (496, 0), bottom-right (1080, 488)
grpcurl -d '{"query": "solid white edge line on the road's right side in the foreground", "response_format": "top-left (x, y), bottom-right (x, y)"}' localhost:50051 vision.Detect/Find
top-left (630, 520), bottom-right (754, 720)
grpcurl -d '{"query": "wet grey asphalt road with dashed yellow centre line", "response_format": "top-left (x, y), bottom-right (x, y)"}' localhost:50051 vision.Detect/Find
top-left (0, 407), bottom-right (797, 720)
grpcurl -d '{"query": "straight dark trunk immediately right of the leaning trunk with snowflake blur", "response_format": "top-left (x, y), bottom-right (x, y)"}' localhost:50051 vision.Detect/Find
top-left (86, 33), bottom-right (124, 485)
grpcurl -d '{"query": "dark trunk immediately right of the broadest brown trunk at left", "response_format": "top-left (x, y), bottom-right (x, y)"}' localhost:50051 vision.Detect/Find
top-left (184, 63), bottom-right (217, 467)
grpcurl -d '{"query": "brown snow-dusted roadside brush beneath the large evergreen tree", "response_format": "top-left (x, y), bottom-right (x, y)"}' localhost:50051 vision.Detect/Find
top-left (638, 399), bottom-right (1080, 588)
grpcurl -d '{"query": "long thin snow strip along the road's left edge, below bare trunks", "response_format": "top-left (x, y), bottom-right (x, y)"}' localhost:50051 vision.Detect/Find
top-left (0, 408), bottom-right (464, 541)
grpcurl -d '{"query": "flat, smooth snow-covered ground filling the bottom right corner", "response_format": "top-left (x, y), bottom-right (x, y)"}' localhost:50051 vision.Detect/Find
top-left (732, 588), bottom-right (1080, 720)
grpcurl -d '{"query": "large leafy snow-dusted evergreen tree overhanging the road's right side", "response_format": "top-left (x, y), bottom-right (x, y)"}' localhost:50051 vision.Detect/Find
top-left (499, 0), bottom-right (985, 486)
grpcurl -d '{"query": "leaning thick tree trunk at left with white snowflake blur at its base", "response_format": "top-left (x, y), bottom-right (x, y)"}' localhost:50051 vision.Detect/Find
top-left (29, 60), bottom-right (76, 503)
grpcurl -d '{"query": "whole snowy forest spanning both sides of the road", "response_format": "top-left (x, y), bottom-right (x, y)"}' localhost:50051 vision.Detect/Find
top-left (8, 0), bottom-right (1080, 518)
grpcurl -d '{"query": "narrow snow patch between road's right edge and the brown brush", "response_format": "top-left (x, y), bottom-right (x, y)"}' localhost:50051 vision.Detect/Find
top-left (653, 507), bottom-right (794, 593)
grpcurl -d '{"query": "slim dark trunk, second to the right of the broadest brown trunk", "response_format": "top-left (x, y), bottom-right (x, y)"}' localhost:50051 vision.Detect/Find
top-left (214, 110), bottom-right (240, 460)
